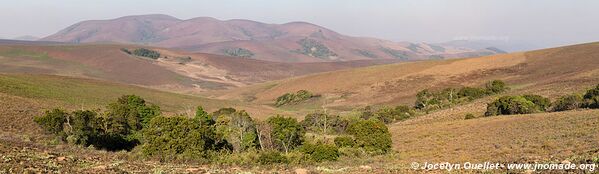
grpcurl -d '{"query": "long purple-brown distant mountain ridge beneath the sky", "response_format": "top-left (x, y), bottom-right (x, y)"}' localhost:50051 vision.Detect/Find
top-left (41, 14), bottom-right (500, 62)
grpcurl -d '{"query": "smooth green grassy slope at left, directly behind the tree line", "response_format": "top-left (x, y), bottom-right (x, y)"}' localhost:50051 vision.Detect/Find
top-left (0, 75), bottom-right (233, 111)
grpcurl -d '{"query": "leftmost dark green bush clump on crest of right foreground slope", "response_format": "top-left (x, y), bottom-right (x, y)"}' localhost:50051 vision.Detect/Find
top-left (485, 96), bottom-right (540, 116)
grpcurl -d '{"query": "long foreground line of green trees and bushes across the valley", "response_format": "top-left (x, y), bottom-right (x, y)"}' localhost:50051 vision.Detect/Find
top-left (34, 95), bottom-right (392, 164)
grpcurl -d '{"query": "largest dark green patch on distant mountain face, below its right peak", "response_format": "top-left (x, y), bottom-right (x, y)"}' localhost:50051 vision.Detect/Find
top-left (294, 38), bottom-right (337, 59)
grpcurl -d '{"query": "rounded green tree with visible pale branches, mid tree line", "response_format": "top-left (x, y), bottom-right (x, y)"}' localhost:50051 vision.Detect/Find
top-left (267, 115), bottom-right (304, 153)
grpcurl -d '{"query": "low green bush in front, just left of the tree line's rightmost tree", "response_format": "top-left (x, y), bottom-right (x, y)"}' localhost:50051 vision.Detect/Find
top-left (300, 143), bottom-right (339, 162)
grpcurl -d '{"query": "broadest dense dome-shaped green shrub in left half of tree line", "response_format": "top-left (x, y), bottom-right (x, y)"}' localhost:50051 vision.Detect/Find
top-left (142, 116), bottom-right (215, 159)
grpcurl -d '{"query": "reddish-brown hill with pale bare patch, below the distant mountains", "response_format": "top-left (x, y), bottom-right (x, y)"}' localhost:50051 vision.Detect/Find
top-left (0, 40), bottom-right (394, 92)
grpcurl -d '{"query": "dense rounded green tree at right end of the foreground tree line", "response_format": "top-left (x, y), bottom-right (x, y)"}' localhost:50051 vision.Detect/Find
top-left (347, 119), bottom-right (391, 153)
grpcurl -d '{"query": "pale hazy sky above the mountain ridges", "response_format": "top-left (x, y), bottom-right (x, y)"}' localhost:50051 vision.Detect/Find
top-left (0, 0), bottom-right (599, 46)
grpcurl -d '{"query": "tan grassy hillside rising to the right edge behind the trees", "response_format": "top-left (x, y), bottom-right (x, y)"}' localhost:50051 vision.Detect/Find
top-left (212, 43), bottom-right (599, 108)
